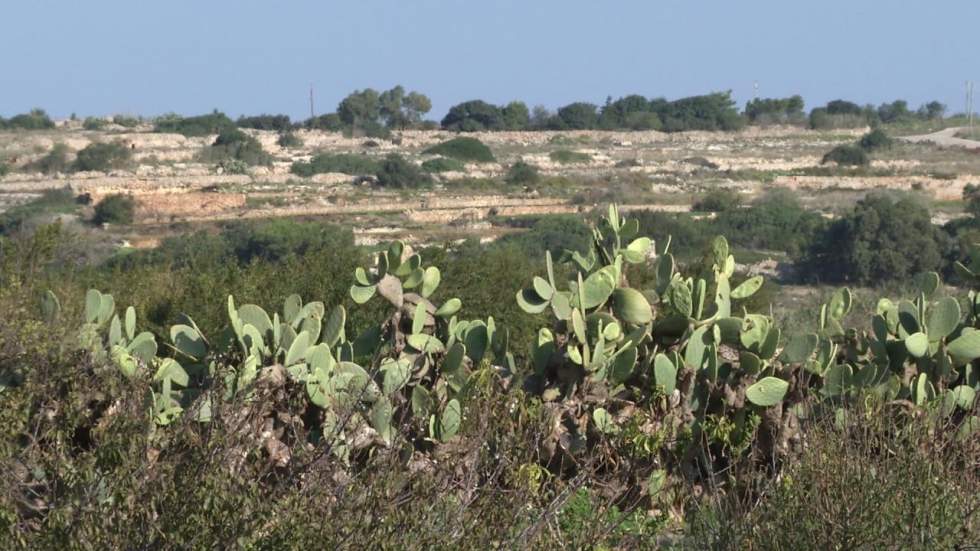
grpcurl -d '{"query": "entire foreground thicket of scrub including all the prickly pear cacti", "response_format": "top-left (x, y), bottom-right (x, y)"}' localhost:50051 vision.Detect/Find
top-left (0, 209), bottom-right (980, 548)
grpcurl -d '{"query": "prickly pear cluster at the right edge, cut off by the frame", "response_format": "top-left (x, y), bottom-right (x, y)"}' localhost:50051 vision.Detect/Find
top-left (814, 272), bottom-right (980, 435)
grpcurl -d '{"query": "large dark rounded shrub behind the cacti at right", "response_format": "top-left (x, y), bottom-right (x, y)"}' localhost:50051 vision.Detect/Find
top-left (804, 195), bottom-right (952, 284)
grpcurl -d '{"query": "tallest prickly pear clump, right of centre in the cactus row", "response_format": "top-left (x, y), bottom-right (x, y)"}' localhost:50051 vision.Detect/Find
top-left (517, 206), bottom-right (788, 464)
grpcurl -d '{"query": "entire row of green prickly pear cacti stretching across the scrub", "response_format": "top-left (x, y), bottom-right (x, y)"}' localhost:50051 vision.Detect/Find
top-left (41, 206), bottom-right (980, 472)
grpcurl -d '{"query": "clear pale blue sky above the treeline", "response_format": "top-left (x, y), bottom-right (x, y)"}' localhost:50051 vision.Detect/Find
top-left (0, 0), bottom-right (980, 119)
